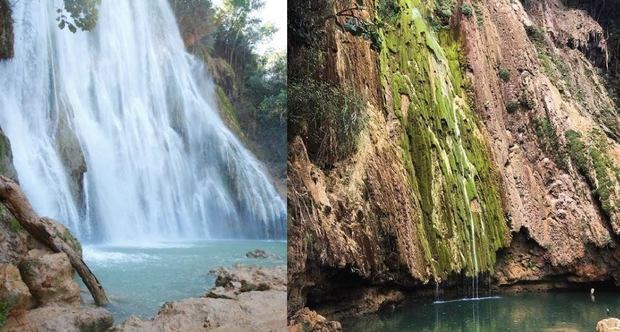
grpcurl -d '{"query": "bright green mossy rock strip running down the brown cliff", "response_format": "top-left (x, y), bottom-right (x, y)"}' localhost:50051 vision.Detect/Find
top-left (379, 0), bottom-right (509, 280)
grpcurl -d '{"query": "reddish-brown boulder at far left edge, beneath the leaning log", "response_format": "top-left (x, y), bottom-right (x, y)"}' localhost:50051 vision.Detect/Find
top-left (0, 264), bottom-right (32, 311)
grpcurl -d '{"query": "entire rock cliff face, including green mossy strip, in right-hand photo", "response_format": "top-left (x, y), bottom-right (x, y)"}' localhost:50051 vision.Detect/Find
top-left (288, 0), bottom-right (620, 315)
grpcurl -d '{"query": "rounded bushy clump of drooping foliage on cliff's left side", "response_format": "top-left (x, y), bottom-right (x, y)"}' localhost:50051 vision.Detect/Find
top-left (289, 78), bottom-right (366, 167)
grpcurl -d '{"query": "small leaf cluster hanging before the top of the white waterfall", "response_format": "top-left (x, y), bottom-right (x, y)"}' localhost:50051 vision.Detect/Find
top-left (56, 0), bottom-right (101, 33)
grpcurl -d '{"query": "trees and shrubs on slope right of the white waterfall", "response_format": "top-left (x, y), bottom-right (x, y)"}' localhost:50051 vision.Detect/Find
top-left (170, 0), bottom-right (287, 179)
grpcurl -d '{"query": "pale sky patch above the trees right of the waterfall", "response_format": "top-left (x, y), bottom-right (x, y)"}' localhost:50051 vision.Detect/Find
top-left (213, 0), bottom-right (286, 54)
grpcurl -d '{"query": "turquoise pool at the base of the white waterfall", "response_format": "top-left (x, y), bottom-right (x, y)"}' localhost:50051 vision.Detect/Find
top-left (81, 240), bottom-right (286, 324)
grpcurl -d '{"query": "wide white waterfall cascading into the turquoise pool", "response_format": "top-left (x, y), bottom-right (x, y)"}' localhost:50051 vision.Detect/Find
top-left (0, 0), bottom-right (286, 243)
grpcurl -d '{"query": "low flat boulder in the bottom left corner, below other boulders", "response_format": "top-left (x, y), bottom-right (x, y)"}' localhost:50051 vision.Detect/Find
top-left (2, 305), bottom-right (114, 332)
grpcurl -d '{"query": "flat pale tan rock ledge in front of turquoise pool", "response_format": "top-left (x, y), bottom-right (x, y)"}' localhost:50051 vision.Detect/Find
top-left (114, 265), bottom-right (286, 332)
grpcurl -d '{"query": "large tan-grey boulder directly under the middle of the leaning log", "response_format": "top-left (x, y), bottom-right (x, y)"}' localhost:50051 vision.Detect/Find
top-left (19, 249), bottom-right (80, 305)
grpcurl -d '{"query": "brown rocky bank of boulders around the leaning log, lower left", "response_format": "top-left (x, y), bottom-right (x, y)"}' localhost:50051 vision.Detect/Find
top-left (0, 128), bottom-right (113, 332)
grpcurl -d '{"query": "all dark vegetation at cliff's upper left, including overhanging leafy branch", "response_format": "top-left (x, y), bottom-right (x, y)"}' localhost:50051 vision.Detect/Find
top-left (288, 0), bottom-right (370, 169)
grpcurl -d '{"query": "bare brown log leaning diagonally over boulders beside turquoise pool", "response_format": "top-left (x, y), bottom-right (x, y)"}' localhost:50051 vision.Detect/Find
top-left (0, 175), bottom-right (110, 306)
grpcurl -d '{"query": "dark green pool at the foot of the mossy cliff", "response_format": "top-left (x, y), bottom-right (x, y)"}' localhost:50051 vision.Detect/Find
top-left (342, 290), bottom-right (620, 332)
